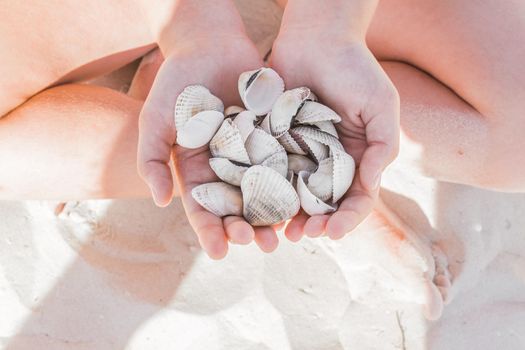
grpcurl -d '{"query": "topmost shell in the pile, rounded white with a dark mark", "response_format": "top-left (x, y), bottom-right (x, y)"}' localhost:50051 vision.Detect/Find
top-left (238, 68), bottom-right (284, 115)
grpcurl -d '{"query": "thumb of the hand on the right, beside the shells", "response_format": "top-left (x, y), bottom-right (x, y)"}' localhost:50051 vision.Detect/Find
top-left (359, 98), bottom-right (400, 191)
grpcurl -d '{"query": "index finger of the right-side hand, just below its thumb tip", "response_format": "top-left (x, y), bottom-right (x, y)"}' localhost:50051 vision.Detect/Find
top-left (325, 173), bottom-right (379, 239)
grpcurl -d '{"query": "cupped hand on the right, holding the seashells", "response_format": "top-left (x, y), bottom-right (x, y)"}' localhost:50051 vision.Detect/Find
top-left (271, 28), bottom-right (400, 241)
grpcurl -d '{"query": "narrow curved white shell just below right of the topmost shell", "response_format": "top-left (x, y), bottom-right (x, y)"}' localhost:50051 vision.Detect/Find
top-left (270, 87), bottom-right (310, 137)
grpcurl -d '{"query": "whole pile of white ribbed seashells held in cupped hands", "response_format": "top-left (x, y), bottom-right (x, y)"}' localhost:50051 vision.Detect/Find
top-left (175, 68), bottom-right (355, 226)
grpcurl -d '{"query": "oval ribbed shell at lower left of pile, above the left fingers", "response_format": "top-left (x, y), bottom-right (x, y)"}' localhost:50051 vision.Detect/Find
top-left (191, 182), bottom-right (243, 217)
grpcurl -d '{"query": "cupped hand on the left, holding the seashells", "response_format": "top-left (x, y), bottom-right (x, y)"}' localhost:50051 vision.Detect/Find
top-left (138, 31), bottom-right (277, 259)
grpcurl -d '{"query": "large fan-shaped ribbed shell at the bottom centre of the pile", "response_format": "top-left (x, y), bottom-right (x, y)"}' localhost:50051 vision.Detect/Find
top-left (241, 165), bottom-right (300, 226)
